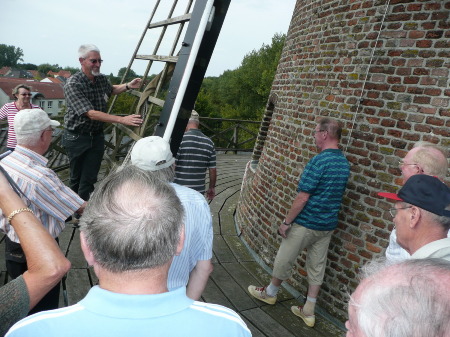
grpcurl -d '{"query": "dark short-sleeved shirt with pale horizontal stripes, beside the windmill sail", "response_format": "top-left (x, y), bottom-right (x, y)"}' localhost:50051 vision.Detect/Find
top-left (174, 129), bottom-right (216, 194)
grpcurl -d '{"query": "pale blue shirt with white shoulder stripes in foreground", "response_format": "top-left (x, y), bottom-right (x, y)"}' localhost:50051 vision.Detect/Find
top-left (6, 286), bottom-right (251, 337)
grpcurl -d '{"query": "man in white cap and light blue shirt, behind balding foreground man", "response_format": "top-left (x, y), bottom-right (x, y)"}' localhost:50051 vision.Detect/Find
top-left (131, 136), bottom-right (213, 300)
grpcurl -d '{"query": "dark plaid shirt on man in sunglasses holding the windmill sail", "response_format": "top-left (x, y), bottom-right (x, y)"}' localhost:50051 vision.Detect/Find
top-left (64, 71), bottom-right (113, 132)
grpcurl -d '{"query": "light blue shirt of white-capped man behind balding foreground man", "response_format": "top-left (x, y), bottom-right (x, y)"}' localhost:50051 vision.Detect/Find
top-left (167, 183), bottom-right (214, 290)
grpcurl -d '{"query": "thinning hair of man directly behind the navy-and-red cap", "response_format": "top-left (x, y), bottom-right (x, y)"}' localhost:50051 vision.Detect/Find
top-left (412, 141), bottom-right (448, 180)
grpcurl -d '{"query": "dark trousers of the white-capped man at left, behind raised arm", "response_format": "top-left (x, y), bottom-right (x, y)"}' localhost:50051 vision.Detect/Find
top-left (5, 237), bottom-right (60, 315)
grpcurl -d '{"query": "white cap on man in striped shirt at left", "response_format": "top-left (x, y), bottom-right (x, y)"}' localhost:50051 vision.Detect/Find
top-left (14, 109), bottom-right (60, 135)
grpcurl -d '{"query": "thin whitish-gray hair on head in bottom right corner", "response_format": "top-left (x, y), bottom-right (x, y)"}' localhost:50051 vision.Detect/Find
top-left (350, 259), bottom-right (450, 337)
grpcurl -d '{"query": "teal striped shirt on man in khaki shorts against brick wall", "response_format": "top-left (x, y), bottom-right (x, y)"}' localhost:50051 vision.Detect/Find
top-left (294, 149), bottom-right (350, 231)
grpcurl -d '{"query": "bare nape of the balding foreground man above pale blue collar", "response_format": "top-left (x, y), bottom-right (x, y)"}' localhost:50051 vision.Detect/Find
top-left (95, 266), bottom-right (169, 295)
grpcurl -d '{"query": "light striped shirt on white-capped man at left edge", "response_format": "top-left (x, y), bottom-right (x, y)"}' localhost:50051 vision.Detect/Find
top-left (0, 145), bottom-right (84, 243)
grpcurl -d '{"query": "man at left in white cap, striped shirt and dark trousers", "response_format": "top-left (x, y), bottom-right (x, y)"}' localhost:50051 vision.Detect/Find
top-left (0, 109), bottom-right (86, 313)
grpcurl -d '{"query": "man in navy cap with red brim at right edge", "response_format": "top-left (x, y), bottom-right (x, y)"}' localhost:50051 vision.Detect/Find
top-left (378, 174), bottom-right (450, 261)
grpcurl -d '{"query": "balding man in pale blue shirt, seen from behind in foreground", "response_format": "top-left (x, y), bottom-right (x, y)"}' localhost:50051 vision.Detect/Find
top-left (6, 165), bottom-right (251, 337)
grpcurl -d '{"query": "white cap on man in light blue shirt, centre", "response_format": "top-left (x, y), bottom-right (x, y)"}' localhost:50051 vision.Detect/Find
top-left (131, 136), bottom-right (175, 171)
